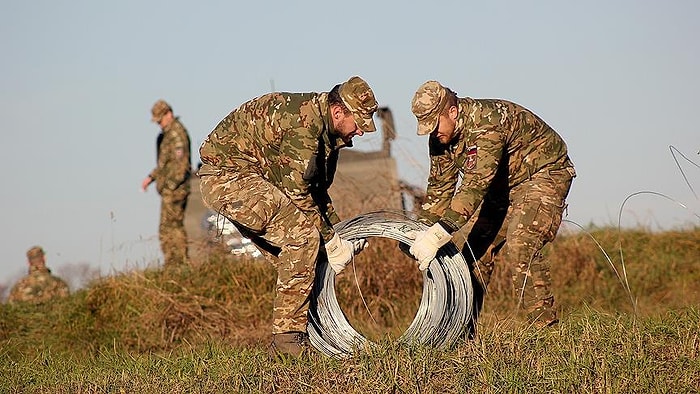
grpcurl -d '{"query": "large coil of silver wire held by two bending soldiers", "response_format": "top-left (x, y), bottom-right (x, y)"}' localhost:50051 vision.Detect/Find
top-left (308, 211), bottom-right (474, 358)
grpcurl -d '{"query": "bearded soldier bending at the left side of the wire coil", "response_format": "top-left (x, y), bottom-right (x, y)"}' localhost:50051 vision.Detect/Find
top-left (198, 77), bottom-right (377, 356)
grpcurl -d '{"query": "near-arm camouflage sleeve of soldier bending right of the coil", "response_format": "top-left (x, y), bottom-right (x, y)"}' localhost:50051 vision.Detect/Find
top-left (440, 129), bottom-right (505, 231)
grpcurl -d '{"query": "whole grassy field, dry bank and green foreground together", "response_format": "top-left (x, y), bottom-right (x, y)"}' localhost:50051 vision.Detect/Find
top-left (0, 229), bottom-right (700, 393)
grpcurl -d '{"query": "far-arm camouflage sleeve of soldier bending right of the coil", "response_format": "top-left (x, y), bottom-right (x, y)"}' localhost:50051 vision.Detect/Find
top-left (419, 137), bottom-right (459, 224)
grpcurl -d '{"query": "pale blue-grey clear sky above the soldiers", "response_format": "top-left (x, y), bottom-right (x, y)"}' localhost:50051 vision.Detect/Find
top-left (0, 0), bottom-right (700, 282)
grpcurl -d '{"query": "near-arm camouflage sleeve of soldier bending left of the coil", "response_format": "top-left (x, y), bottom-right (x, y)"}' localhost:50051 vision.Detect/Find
top-left (280, 126), bottom-right (335, 241)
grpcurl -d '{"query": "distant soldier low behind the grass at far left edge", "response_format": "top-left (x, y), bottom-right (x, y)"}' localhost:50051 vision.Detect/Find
top-left (7, 246), bottom-right (70, 304)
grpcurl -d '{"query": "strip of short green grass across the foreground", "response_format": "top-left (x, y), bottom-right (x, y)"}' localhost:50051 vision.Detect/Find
top-left (0, 308), bottom-right (700, 393)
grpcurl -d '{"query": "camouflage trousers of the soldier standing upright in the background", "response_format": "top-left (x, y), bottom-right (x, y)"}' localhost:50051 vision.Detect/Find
top-left (158, 191), bottom-right (187, 267)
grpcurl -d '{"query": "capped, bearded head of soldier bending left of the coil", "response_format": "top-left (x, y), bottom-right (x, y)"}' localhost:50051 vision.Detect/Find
top-left (328, 76), bottom-right (377, 144)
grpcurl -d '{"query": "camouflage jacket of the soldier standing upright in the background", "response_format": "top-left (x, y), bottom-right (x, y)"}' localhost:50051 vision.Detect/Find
top-left (149, 118), bottom-right (192, 196)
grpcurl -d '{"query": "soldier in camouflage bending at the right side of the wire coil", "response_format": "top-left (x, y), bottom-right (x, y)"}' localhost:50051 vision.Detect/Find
top-left (411, 81), bottom-right (576, 326)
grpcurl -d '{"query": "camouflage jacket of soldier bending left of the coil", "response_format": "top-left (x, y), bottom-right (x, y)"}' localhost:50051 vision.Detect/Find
top-left (199, 93), bottom-right (346, 241)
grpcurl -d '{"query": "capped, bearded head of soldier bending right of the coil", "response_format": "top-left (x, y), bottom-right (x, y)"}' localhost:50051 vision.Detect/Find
top-left (411, 81), bottom-right (459, 144)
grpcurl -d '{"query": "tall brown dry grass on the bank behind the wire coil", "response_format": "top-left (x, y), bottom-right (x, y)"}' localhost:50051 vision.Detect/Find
top-left (0, 229), bottom-right (700, 352)
